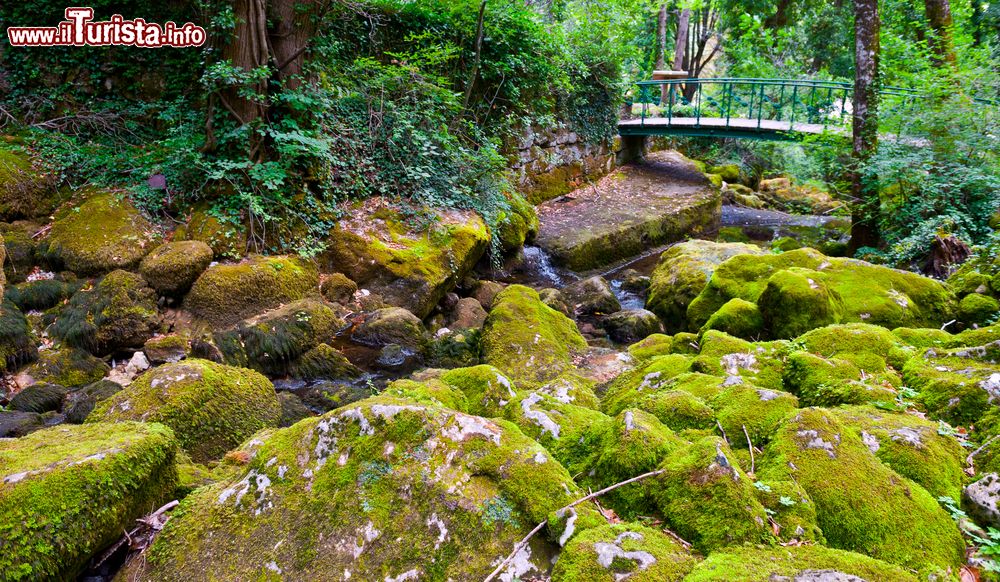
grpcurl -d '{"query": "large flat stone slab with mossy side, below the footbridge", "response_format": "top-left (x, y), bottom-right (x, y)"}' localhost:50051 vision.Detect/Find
top-left (536, 151), bottom-right (722, 271)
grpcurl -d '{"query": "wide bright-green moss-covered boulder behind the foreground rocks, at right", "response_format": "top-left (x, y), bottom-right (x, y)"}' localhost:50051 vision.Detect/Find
top-left (687, 248), bottom-right (956, 337)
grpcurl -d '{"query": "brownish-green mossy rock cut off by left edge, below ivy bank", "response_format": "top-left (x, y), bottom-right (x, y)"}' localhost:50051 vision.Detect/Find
top-left (0, 145), bottom-right (60, 222)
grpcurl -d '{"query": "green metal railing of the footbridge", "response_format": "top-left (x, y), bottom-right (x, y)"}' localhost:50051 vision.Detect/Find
top-left (633, 78), bottom-right (921, 133)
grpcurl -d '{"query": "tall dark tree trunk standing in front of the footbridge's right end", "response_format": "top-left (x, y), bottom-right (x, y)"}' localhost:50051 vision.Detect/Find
top-left (850, 0), bottom-right (879, 251)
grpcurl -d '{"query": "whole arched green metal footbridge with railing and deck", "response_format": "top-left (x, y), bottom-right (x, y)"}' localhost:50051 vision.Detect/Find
top-left (618, 78), bottom-right (993, 140)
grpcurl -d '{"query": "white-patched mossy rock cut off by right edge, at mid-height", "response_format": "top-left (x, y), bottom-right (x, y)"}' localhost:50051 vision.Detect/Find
top-left (903, 342), bottom-right (1000, 426)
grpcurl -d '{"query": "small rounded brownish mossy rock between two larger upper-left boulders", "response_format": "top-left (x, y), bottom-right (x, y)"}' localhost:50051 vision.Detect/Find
top-left (139, 241), bottom-right (214, 297)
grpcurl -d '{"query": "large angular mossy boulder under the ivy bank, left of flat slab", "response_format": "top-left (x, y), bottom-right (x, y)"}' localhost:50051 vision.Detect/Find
top-left (320, 200), bottom-right (489, 318)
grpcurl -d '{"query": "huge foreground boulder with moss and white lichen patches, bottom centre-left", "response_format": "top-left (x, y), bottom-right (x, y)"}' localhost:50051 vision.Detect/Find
top-left (133, 396), bottom-right (604, 580)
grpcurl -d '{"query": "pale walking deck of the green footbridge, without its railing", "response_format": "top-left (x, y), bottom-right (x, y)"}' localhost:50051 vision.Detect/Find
top-left (618, 117), bottom-right (832, 139)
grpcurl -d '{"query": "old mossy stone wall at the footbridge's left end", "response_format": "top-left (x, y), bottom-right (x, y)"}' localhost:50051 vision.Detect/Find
top-left (510, 127), bottom-right (668, 204)
